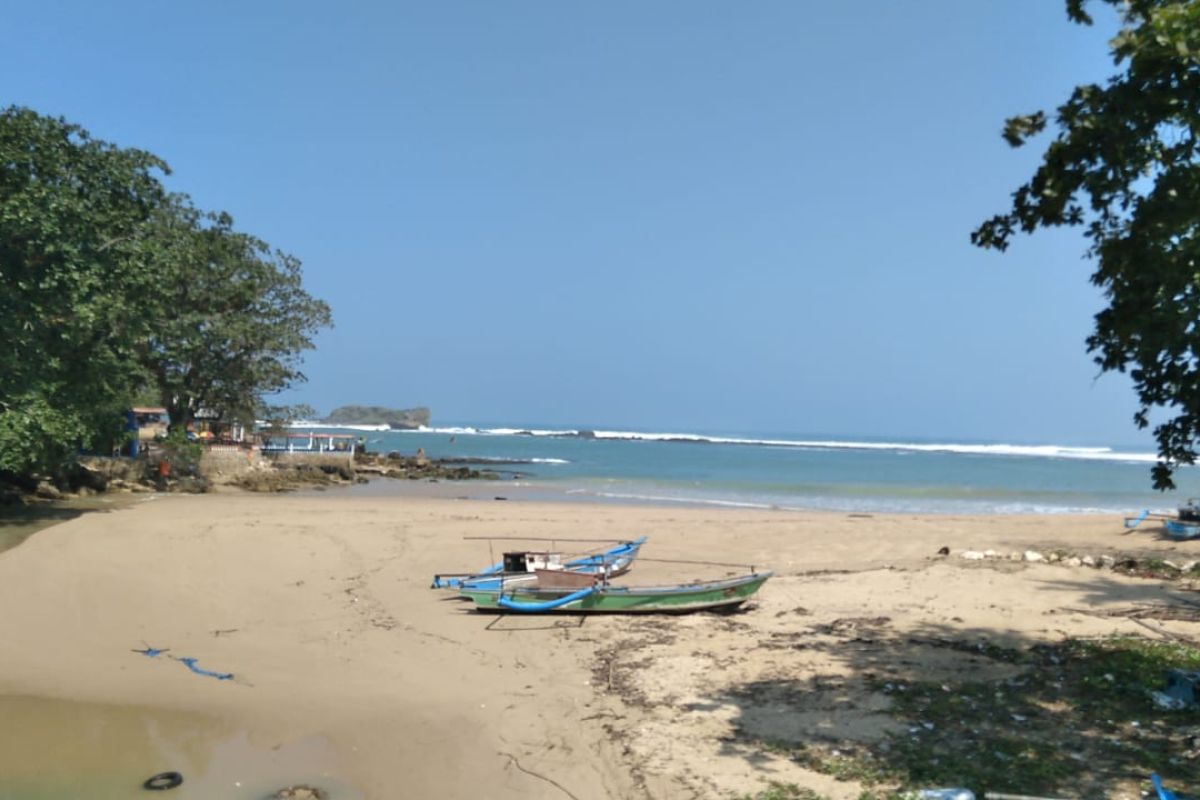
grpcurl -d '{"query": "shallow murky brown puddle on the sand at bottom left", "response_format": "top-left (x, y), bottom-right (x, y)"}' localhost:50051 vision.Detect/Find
top-left (0, 697), bottom-right (362, 800)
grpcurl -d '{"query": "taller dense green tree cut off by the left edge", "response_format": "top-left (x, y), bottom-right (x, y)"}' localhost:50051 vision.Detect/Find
top-left (0, 108), bottom-right (167, 473)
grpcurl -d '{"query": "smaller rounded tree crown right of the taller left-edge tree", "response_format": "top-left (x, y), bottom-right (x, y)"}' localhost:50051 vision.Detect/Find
top-left (137, 197), bottom-right (331, 429)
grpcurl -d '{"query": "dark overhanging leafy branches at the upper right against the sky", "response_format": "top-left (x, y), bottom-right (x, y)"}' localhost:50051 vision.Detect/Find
top-left (971, 0), bottom-right (1200, 489)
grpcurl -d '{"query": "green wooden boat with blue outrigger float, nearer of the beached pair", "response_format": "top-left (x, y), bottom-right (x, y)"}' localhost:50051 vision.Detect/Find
top-left (460, 571), bottom-right (773, 614)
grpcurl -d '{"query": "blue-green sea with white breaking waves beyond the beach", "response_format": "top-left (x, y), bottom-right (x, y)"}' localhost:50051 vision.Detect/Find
top-left (298, 423), bottom-right (1200, 513)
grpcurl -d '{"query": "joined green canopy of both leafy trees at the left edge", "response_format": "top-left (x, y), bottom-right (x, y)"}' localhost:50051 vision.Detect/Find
top-left (0, 107), bottom-right (330, 474)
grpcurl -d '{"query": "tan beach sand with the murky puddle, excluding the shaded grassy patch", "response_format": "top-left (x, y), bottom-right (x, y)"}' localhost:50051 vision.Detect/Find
top-left (0, 493), bottom-right (1200, 800)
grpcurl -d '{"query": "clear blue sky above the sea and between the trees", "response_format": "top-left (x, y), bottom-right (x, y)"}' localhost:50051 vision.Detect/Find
top-left (0, 0), bottom-right (1144, 443)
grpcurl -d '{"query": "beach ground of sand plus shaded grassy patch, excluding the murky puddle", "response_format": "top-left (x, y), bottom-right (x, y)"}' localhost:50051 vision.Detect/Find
top-left (0, 496), bottom-right (1200, 800)
